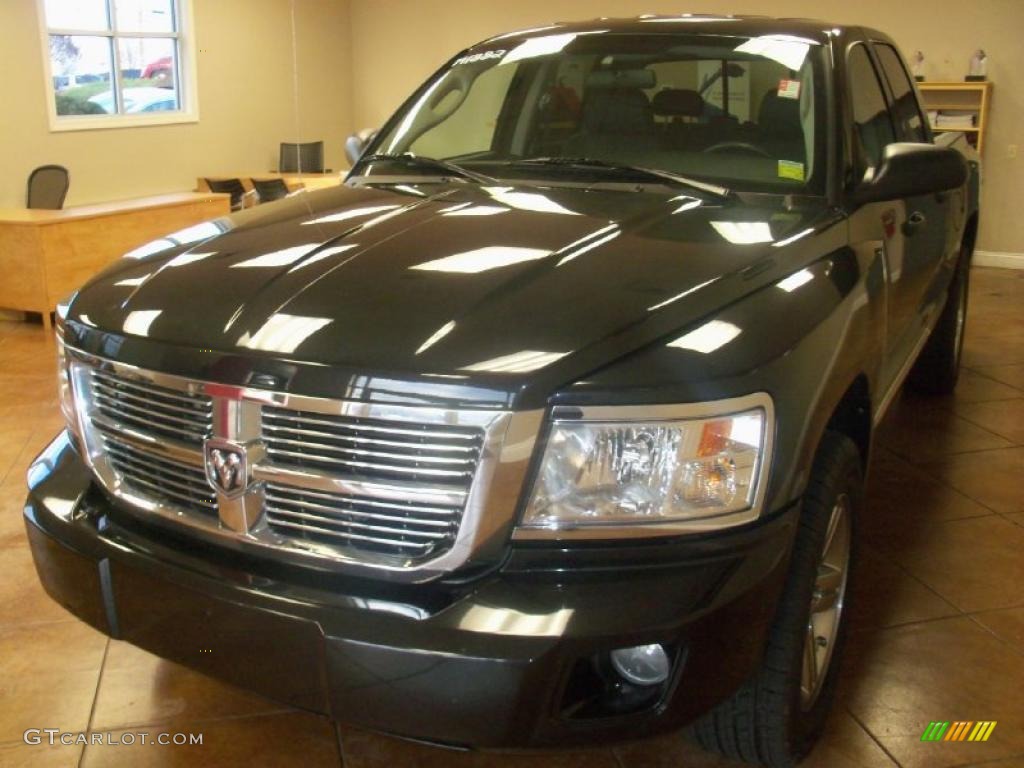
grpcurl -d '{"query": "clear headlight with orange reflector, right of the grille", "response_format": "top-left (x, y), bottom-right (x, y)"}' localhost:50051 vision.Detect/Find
top-left (516, 393), bottom-right (774, 539)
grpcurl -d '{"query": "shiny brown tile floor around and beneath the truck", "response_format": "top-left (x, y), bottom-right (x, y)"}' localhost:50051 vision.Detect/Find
top-left (0, 269), bottom-right (1024, 768)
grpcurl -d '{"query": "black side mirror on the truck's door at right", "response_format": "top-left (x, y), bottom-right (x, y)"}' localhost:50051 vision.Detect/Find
top-left (854, 143), bottom-right (968, 203)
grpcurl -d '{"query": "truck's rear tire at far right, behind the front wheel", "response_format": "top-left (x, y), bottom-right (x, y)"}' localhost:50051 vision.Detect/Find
top-left (907, 254), bottom-right (971, 394)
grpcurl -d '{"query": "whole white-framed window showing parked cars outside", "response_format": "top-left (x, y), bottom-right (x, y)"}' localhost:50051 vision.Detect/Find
top-left (40, 0), bottom-right (195, 129)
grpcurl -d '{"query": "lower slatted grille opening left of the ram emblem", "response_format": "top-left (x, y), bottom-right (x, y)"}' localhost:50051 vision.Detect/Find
top-left (102, 430), bottom-right (217, 518)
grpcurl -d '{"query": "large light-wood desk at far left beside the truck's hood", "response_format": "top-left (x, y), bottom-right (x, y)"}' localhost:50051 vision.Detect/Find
top-left (0, 193), bottom-right (230, 329)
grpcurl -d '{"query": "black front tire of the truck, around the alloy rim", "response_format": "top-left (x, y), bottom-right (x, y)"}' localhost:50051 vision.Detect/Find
top-left (692, 431), bottom-right (863, 768)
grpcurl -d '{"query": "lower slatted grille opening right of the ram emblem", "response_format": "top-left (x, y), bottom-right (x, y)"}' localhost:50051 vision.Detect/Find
top-left (266, 483), bottom-right (462, 558)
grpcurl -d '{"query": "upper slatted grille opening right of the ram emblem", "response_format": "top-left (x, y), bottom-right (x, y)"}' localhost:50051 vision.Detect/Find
top-left (263, 408), bottom-right (483, 487)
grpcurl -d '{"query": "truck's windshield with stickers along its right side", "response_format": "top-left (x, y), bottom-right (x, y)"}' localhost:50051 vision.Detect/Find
top-left (367, 32), bottom-right (825, 194)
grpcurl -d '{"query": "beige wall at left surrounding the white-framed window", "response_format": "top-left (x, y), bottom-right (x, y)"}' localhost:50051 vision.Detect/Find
top-left (0, 0), bottom-right (351, 207)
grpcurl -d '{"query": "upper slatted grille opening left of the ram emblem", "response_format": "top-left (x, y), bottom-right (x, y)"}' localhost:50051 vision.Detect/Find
top-left (91, 369), bottom-right (213, 444)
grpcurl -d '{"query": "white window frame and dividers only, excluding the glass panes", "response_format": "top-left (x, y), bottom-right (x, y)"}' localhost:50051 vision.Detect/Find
top-left (36, 0), bottom-right (199, 132)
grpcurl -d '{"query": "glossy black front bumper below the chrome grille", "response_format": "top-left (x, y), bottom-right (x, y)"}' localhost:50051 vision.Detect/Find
top-left (25, 434), bottom-right (797, 749)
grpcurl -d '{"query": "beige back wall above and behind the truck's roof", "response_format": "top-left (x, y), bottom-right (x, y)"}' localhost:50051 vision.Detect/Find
top-left (350, 0), bottom-right (1024, 253)
